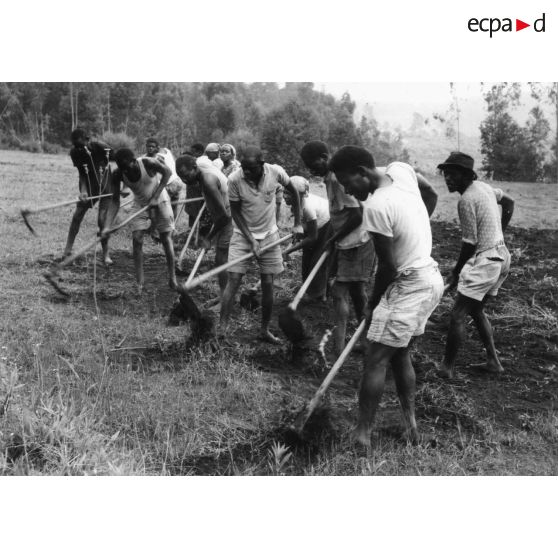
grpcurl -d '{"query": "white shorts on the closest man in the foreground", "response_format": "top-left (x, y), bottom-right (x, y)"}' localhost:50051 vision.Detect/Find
top-left (366, 264), bottom-right (444, 348)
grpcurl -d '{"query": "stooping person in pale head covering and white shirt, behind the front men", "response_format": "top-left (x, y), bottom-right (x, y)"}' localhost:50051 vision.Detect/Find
top-left (283, 176), bottom-right (331, 301)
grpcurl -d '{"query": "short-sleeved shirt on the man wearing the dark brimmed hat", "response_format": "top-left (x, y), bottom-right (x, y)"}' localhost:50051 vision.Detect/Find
top-left (457, 180), bottom-right (504, 253)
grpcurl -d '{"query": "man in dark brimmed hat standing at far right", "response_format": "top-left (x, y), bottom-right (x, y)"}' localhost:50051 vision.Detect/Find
top-left (438, 151), bottom-right (514, 378)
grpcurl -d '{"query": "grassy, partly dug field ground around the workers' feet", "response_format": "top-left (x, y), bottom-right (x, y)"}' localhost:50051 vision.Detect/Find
top-left (0, 151), bottom-right (558, 475)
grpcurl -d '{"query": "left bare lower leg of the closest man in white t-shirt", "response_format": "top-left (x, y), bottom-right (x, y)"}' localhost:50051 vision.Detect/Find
top-left (353, 341), bottom-right (397, 447)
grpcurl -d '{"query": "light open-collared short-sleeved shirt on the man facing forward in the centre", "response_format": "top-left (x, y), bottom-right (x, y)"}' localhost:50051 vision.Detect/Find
top-left (229, 163), bottom-right (289, 240)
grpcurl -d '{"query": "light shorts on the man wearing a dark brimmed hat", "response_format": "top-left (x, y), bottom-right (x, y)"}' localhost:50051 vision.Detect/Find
top-left (457, 244), bottom-right (511, 301)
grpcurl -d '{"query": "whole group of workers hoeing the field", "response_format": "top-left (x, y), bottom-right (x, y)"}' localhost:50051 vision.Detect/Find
top-left (60, 129), bottom-right (514, 447)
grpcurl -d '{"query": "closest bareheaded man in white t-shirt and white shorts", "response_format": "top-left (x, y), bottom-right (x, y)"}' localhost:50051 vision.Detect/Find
top-left (329, 145), bottom-right (444, 447)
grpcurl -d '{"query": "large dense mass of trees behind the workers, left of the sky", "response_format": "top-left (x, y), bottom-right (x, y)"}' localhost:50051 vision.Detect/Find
top-left (0, 82), bottom-right (409, 173)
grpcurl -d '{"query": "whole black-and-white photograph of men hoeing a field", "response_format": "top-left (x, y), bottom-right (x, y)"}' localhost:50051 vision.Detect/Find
top-left (0, 81), bottom-right (558, 477)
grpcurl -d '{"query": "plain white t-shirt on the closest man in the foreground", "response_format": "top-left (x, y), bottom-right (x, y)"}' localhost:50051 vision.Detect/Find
top-left (362, 163), bottom-right (434, 273)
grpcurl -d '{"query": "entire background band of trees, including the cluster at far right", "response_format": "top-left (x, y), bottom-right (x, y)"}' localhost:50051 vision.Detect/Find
top-left (0, 82), bottom-right (558, 182)
